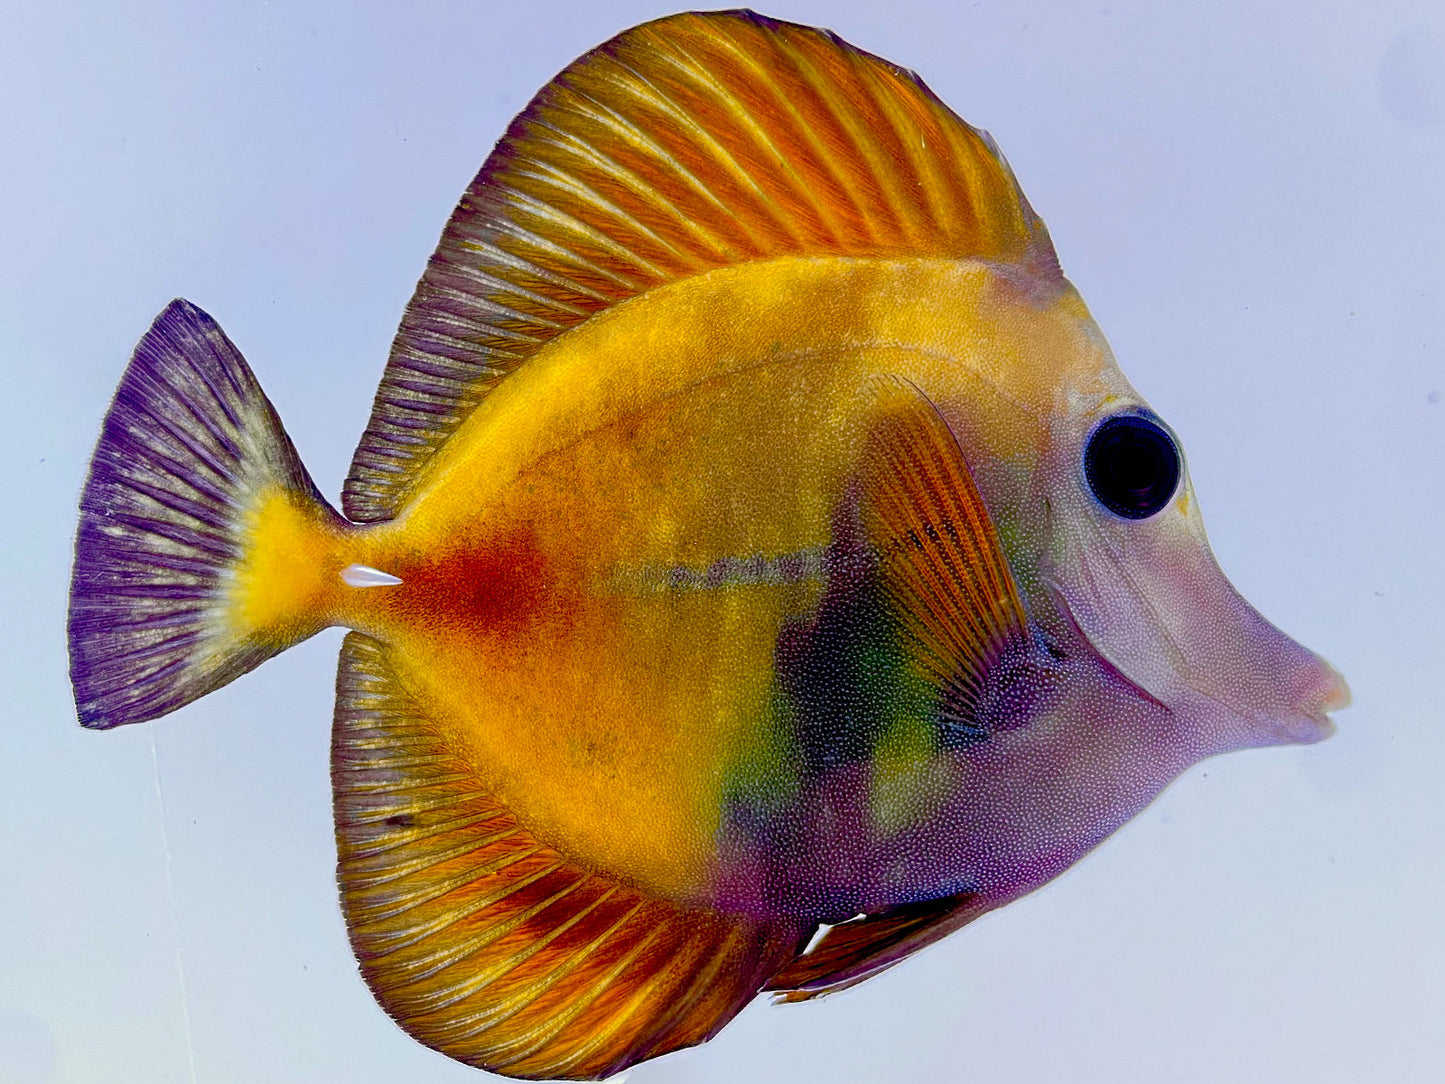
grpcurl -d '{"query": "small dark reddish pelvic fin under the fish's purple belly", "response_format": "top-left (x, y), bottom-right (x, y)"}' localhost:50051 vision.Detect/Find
top-left (767, 892), bottom-right (987, 1002)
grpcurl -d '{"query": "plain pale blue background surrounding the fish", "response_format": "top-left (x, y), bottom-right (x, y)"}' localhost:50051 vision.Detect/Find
top-left (0, 0), bottom-right (1445, 1084)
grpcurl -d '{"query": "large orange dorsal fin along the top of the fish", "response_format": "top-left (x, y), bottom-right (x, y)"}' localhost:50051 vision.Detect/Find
top-left (342, 12), bottom-right (1058, 522)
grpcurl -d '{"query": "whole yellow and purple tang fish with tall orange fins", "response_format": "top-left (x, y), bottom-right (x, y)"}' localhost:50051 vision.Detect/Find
top-left (68, 12), bottom-right (1348, 1078)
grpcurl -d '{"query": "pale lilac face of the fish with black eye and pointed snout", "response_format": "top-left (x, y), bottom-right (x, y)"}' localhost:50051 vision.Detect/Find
top-left (1039, 303), bottom-right (1350, 754)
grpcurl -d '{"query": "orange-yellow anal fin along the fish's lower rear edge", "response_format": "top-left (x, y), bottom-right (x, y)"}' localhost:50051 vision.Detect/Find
top-left (332, 633), bottom-right (808, 1078)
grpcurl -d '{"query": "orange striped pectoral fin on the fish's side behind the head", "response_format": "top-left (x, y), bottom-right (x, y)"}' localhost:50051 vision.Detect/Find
top-left (860, 377), bottom-right (1027, 727)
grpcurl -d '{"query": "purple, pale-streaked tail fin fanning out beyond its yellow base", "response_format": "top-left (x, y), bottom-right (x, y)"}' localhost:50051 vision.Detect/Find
top-left (69, 301), bottom-right (342, 728)
